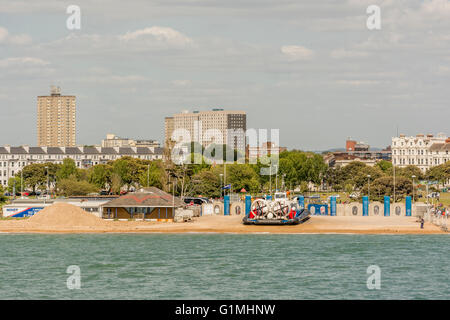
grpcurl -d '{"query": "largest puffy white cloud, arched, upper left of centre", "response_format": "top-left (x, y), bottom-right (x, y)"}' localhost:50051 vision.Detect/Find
top-left (119, 26), bottom-right (193, 46)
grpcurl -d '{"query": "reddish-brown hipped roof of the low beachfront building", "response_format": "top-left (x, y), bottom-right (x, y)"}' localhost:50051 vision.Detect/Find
top-left (103, 187), bottom-right (185, 208)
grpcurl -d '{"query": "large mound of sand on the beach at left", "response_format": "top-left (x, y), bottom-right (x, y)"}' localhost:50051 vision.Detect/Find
top-left (27, 202), bottom-right (105, 228)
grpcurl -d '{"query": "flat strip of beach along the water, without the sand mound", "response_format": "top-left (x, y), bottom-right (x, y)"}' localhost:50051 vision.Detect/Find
top-left (0, 216), bottom-right (449, 235)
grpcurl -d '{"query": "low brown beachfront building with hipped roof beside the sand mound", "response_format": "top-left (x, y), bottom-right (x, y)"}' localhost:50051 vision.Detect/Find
top-left (103, 187), bottom-right (185, 220)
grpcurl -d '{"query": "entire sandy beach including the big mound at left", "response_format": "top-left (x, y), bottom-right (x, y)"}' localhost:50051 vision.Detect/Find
top-left (0, 205), bottom-right (445, 234)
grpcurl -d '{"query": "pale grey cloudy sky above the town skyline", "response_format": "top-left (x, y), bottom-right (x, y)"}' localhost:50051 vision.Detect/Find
top-left (0, 0), bottom-right (450, 150)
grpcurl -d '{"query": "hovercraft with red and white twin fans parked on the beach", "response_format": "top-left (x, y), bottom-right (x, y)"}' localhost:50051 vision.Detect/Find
top-left (242, 199), bottom-right (310, 225)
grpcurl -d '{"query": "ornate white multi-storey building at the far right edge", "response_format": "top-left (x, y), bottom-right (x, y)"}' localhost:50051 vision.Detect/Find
top-left (391, 133), bottom-right (450, 172)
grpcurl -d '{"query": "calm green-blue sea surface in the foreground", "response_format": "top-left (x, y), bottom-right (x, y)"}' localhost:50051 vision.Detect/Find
top-left (0, 234), bottom-right (450, 299)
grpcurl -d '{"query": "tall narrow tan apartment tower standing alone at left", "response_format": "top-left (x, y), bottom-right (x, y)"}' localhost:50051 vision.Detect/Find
top-left (37, 86), bottom-right (76, 147)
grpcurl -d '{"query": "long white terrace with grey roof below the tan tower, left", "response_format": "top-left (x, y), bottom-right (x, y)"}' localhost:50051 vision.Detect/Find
top-left (0, 146), bottom-right (163, 186)
